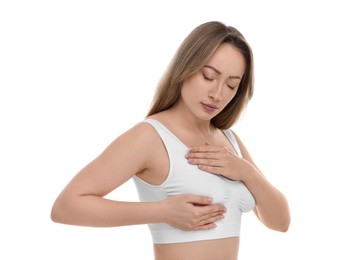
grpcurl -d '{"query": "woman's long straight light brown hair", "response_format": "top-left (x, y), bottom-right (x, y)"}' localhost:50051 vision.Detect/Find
top-left (147, 21), bottom-right (253, 129)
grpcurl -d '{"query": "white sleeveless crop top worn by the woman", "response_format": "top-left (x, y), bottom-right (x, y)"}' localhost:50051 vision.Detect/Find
top-left (133, 119), bottom-right (255, 244)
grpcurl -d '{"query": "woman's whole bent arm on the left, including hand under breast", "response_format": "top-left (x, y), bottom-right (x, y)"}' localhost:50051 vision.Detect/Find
top-left (51, 124), bottom-right (225, 230)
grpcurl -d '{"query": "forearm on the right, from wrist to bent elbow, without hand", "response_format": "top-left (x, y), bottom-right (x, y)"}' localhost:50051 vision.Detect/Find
top-left (244, 166), bottom-right (290, 232)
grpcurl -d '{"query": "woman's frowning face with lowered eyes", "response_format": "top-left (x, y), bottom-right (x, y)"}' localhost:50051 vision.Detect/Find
top-left (178, 43), bottom-right (246, 120)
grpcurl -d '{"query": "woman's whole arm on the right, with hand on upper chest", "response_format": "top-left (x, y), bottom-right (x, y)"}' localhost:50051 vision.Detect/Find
top-left (186, 133), bottom-right (290, 232)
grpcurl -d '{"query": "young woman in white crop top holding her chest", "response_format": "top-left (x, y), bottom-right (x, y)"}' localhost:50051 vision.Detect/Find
top-left (51, 21), bottom-right (290, 260)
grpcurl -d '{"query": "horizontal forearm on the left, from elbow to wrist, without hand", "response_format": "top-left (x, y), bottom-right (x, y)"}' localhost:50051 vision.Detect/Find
top-left (51, 195), bottom-right (163, 227)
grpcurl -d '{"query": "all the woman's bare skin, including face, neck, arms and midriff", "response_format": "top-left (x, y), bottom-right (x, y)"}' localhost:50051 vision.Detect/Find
top-left (51, 44), bottom-right (290, 260)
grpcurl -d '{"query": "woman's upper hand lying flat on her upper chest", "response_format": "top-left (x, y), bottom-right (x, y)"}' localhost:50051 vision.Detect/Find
top-left (186, 145), bottom-right (252, 181)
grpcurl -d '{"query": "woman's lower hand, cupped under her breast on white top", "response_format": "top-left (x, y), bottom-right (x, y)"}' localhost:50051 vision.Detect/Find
top-left (162, 194), bottom-right (226, 231)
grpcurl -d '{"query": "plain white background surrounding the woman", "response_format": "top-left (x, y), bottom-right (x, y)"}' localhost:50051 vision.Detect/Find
top-left (0, 0), bottom-right (342, 260)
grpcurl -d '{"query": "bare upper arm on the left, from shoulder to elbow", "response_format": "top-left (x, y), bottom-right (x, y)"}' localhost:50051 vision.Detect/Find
top-left (53, 123), bottom-right (164, 196)
